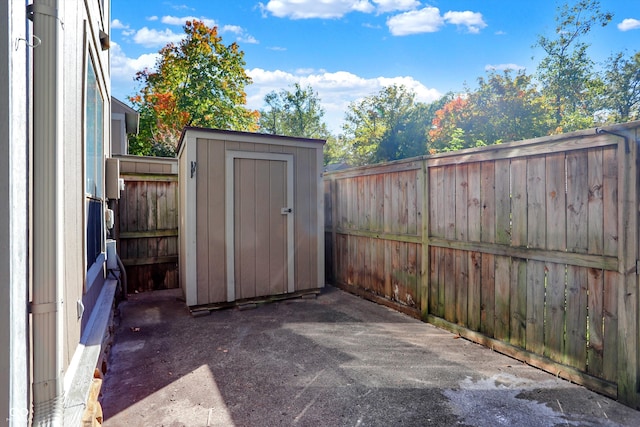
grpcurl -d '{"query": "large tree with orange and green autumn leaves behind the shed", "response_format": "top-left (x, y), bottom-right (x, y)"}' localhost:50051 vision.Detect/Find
top-left (130, 21), bottom-right (258, 155)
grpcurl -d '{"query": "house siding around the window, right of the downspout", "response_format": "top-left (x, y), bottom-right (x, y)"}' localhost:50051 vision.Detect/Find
top-left (60, 0), bottom-right (111, 382)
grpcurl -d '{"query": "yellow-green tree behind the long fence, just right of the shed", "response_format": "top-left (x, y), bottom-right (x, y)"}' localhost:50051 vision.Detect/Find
top-left (343, 85), bottom-right (432, 165)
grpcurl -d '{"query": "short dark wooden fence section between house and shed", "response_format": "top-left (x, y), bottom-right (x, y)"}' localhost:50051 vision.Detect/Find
top-left (116, 156), bottom-right (179, 293)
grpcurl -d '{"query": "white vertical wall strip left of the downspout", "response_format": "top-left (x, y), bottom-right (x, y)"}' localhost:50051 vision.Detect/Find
top-left (0, 0), bottom-right (30, 425)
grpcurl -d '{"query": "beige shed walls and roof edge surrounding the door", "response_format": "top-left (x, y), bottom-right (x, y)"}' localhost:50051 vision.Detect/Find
top-left (179, 128), bottom-right (324, 306)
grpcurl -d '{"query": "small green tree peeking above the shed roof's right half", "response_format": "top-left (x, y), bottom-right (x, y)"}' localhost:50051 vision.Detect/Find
top-left (258, 83), bottom-right (329, 139)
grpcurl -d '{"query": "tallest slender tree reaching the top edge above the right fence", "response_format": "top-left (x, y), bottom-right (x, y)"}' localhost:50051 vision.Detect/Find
top-left (537, 0), bottom-right (613, 132)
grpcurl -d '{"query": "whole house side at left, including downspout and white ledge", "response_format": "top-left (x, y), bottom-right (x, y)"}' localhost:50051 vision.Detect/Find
top-left (0, 0), bottom-right (115, 425)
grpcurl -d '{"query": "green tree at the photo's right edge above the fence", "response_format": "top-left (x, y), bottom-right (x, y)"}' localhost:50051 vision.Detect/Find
top-left (604, 51), bottom-right (640, 123)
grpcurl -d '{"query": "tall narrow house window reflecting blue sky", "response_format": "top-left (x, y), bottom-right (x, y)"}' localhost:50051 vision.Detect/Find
top-left (85, 59), bottom-right (104, 269)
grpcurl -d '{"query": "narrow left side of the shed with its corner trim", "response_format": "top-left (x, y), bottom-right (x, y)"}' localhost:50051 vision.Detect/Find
top-left (184, 135), bottom-right (198, 306)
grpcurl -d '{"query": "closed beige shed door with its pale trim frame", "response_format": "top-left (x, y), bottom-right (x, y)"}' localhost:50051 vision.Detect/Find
top-left (227, 151), bottom-right (294, 301)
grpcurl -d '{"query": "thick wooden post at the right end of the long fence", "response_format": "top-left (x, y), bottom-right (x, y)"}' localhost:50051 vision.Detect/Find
top-left (618, 128), bottom-right (640, 409)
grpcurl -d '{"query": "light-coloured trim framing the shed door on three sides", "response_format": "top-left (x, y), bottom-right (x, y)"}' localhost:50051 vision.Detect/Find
top-left (225, 150), bottom-right (296, 302)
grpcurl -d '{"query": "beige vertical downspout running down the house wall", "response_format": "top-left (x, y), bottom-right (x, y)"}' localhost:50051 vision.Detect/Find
top-left (28, 0), bottom-right (64, 426)
